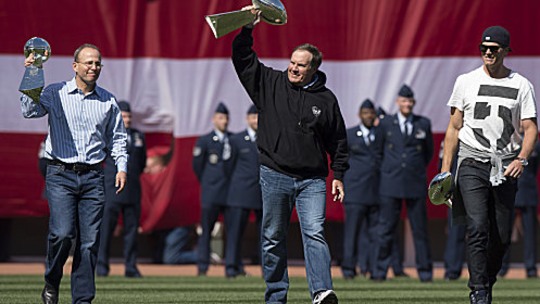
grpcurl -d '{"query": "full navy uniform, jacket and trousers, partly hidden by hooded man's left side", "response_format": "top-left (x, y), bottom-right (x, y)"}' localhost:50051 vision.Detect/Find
top-left (225, 126), bottom-right (262, 277)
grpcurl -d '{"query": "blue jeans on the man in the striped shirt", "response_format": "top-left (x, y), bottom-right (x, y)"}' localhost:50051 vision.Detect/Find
top-left (45, 165), bottom-right (105, 303)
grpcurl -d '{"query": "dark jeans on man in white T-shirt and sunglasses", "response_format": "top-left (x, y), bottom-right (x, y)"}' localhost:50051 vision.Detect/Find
top-left (458, 159), bottom-right (517, 290)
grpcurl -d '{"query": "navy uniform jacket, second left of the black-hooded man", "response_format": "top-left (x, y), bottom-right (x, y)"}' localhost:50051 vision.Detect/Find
top-left (192, 131), bottom-right (232, 208)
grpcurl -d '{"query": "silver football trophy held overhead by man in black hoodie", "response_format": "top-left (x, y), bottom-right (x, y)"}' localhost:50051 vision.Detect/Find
top-left (204, 0), bottom-right (287, 38)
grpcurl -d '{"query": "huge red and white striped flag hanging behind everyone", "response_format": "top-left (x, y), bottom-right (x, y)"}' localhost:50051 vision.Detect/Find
top-left (0, 0), bottom-right (540, 257)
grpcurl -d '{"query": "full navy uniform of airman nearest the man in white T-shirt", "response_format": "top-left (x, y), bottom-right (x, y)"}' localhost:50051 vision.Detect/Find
top-left (372, 86), bottom-right (433, 282)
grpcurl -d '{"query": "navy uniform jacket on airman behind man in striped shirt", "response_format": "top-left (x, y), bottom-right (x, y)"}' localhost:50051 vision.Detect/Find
top-left (104, 129), bottom-right (146, 205)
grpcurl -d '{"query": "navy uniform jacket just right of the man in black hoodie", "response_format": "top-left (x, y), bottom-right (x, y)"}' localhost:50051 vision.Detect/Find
top-left (343, 126), bottom-right (380, 205)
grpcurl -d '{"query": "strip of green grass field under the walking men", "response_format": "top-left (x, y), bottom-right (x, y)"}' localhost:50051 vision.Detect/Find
top-left (0, 275), bottom-right (540, 304)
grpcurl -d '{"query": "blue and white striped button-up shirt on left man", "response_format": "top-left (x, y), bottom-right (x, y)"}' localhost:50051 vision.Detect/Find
top-left (21, 78), bottom-right (128, 172)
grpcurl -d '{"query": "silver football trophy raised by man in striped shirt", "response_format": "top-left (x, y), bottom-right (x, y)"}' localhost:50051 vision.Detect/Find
top-left (19, 37), bottom-right (51, 102)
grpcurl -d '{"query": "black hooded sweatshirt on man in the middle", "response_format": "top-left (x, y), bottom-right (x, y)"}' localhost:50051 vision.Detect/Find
top-left (232, 28), bottom-right (349, 180)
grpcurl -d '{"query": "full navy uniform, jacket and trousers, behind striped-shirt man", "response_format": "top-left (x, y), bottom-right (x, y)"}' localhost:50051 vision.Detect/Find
top-left (96, 102), bottom-right (146, 277)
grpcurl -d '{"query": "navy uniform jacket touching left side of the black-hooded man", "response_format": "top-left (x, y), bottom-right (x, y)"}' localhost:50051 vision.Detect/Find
top-left (227, 130), bottom-right (262, 209)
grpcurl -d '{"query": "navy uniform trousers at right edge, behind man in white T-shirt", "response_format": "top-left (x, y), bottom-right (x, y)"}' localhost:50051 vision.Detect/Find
top-left (501, 206), bottom-right (538, 276)
